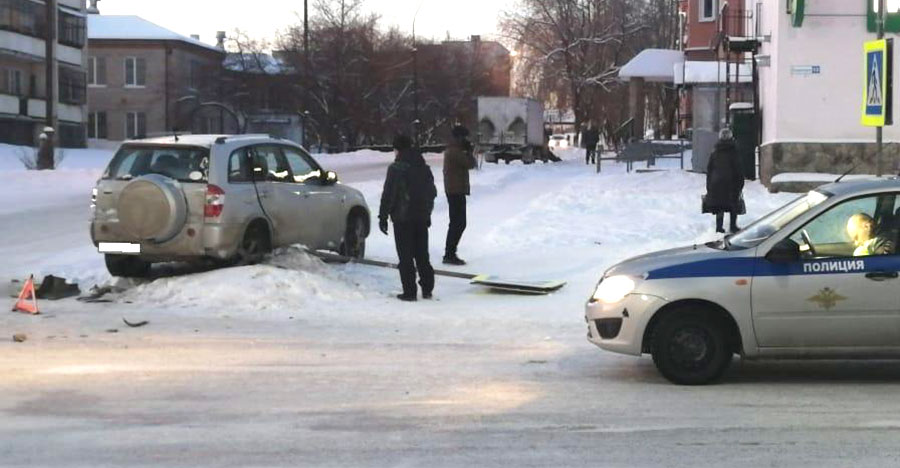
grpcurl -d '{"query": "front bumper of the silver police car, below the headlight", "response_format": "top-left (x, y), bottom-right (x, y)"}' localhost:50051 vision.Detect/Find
top-left (584, 294), bottom-right (666, 356)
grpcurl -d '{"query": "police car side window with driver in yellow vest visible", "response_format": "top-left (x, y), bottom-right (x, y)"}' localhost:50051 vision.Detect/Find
top-left (791, 194), bottom-right (898, 258)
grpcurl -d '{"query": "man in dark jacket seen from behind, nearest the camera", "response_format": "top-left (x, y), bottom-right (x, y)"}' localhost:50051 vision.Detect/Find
top-left (378, 135), bottom-right (437, 301)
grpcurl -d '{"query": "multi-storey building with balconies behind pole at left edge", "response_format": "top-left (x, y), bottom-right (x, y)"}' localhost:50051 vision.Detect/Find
top-left (0, 0), bottom-right (87, 147)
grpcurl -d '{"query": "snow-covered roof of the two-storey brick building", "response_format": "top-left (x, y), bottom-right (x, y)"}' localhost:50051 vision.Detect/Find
top-left (88, 15), bottom-right (223, 52)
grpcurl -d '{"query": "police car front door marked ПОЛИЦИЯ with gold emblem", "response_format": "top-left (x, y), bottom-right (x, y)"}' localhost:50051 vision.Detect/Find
top-left (752, 193), bottom-right (900, 350)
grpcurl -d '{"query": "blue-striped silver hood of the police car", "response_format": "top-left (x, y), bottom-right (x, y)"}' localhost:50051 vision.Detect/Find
top-left (604, 244), bottom-right (740, 279)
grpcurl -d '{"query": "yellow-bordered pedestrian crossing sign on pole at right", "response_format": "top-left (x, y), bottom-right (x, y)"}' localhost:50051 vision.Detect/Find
top-left (862, 39), bottom-right (893, 127)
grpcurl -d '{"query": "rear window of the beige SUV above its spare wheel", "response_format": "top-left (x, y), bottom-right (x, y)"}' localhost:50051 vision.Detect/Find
top-left (103, 145), bottom-right (209, 182)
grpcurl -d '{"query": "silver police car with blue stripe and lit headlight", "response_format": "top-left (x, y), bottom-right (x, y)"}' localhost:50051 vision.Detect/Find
top-left (585, 179), bottom-right (900, 385)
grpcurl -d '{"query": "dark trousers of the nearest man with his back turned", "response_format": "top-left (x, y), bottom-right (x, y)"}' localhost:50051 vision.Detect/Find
top-left (394, 221), bottom-right (434, 296)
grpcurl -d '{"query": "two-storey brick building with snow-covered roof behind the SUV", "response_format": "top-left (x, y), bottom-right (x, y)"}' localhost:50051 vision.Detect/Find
top-left (86, 7), bottom-right (229, 140)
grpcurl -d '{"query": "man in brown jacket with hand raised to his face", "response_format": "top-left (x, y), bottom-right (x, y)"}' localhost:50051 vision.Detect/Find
top-left (444, 125), bottom-right (478, 265)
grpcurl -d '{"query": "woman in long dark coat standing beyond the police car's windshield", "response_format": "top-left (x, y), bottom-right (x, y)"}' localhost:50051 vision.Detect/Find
top-left (703, 128), bottom-right (744, 232)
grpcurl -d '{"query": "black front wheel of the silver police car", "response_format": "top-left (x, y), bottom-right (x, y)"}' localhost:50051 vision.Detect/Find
top-left (652, 312), bottom-right (733, 385)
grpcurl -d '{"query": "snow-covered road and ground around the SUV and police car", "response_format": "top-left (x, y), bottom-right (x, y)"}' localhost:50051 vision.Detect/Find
top-left (0, 147), bottom-right (900, 467)
